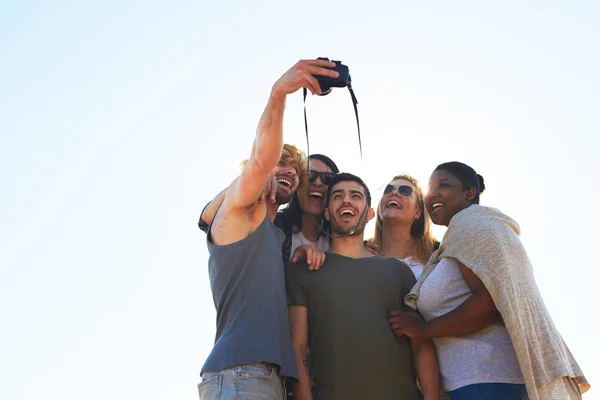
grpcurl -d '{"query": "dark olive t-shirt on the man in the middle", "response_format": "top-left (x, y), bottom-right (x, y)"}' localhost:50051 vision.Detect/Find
top-left (285, 253), bottom-right (421, 400)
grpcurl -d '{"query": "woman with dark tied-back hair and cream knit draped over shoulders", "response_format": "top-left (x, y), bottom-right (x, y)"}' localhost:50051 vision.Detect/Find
top-left (389, 162), bottom-right (589, 400)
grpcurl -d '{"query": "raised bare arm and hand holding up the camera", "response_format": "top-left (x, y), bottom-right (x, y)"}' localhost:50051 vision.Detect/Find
top-left (227, 60), bottom-right (338, 208)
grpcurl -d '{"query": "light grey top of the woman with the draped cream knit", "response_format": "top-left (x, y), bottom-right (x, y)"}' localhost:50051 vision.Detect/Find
top-left (417, 258), bottom-right (525, 391)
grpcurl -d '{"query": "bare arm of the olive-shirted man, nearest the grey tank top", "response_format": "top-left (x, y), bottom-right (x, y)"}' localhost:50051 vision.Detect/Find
top-left (288, 306), bottom-right (312, 400)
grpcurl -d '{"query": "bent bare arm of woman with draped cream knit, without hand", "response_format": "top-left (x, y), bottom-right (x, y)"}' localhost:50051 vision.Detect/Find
top-left (423, 262), bottom-right (500, 338)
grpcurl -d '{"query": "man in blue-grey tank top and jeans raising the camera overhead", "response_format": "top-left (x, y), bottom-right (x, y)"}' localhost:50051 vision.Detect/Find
top-left (198, 60), bottom-right (338, 400)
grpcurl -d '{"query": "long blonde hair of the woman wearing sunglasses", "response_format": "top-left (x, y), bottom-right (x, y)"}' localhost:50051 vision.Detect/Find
top-left (369, 174), bottom-right (436, 264)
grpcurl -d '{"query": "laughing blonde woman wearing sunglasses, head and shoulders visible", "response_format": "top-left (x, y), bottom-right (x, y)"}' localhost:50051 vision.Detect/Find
top-left (370, 175), bottom-right (437, 280)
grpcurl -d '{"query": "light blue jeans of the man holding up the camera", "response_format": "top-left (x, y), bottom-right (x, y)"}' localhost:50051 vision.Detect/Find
top-left (198, 363), bottom-right (285, 400)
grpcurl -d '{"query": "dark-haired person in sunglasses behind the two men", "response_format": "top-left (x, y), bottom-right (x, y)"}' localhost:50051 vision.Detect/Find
top-left (275, 154), bottom-right (339, 262)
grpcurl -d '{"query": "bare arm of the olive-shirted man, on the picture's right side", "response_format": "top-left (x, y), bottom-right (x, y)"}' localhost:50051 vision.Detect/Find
top-left (410, 339), bottom-right (440, 400)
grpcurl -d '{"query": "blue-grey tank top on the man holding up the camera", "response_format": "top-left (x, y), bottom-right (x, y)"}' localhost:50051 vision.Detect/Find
top-left (201, 217), bottom-right (298, 378)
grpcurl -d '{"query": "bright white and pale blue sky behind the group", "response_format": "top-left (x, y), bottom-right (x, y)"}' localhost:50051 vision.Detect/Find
top-left (0, 0), bottom-right (600, 400)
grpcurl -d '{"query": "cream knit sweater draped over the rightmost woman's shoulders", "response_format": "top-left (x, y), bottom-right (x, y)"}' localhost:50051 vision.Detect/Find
top-left (405, 205), bottom-right (590, 400)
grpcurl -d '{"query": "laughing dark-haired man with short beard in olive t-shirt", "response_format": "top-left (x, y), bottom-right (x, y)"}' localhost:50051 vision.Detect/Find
top-left (286, 174), bottom-right (438, 400)
